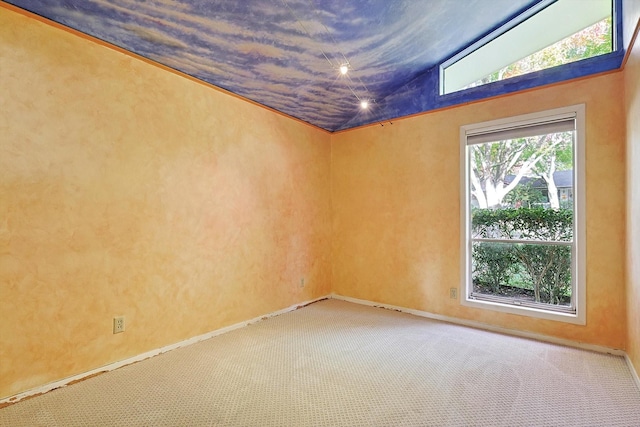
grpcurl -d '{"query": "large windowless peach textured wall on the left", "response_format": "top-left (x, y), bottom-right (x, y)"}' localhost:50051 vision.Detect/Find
top-left (0, 8), bottom-right (331, 398)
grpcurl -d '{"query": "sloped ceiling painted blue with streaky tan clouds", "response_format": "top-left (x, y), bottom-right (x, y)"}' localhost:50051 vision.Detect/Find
top-left (7, 0), bottom-right (539, 131)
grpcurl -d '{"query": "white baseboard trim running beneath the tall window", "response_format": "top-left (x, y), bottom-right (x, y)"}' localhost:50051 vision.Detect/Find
top-left (331, 294), bottom-right (637, 358)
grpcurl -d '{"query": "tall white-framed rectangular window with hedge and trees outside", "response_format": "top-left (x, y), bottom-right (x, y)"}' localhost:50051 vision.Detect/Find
top-left (460, 105), bottom-right (586, 324)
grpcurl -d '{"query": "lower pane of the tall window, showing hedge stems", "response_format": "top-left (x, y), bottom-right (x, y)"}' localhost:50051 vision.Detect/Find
top-left (471, 242), bottom-right (572, 306)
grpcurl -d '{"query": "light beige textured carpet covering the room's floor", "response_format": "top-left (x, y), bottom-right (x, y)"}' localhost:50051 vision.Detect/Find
top-left (0, 300), bottom-right (640, 427)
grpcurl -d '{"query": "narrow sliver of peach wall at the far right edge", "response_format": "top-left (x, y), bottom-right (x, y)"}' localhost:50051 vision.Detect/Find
top-left (624, 17), bottom-right (640, 374)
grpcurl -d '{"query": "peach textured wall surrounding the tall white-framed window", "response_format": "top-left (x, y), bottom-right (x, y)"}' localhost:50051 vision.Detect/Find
top-left (332, 73), bottom-right (626, 348)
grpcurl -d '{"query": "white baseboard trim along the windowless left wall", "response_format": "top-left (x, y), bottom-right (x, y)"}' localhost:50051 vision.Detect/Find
top-left (0, 295), bottom-right (331, 408)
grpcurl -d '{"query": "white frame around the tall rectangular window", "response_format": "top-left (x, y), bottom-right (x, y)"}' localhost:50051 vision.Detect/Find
top-left (460, 104), bottom-right (587, 325)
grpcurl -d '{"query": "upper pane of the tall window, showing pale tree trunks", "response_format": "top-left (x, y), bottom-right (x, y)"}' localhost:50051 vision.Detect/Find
top-left (468, 131), bottom-right (574, 242)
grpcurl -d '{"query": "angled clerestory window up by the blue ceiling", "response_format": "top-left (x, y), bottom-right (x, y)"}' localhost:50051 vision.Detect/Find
top-left (441, 0), bottom-right (613, 94)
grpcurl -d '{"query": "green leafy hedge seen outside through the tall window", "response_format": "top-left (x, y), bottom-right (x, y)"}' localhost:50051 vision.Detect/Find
top-left (471, 208), bottom-right (573, 304)
